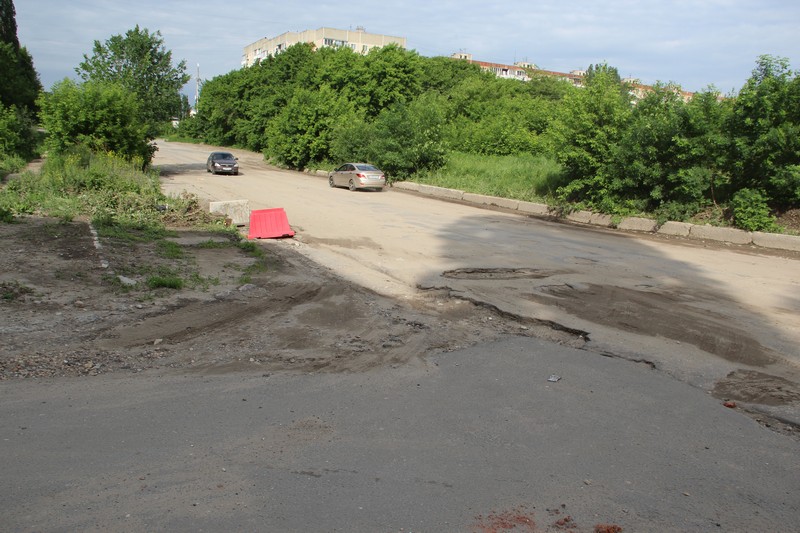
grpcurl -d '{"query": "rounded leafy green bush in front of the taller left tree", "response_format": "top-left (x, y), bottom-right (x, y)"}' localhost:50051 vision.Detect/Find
top-left (39, 79), bottom-right (155, 164)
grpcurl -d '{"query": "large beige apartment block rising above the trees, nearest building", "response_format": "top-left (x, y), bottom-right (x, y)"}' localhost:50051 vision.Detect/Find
top-left (242, 26), bottom-right (406, 67)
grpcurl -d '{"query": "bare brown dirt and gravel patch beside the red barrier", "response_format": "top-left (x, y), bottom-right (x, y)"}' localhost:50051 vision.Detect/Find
top-left (0, 218), bottom-right (584, 379)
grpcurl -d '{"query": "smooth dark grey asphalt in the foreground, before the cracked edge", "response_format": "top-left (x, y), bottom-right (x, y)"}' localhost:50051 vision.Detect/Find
top-left (0, 338), bottom-right (800, 532)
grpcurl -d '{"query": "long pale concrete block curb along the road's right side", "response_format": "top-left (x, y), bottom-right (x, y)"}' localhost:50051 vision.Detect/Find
top-left (391, 181), bottom-right (800, 252)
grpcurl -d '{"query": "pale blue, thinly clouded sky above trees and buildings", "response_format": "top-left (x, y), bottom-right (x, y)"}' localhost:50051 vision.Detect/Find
top-left (14, 0), bottom-right (800, 95)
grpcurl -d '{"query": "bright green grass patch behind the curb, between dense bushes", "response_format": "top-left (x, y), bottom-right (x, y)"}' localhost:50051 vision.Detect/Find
top-left (414, 152), bottom-right (563, 201)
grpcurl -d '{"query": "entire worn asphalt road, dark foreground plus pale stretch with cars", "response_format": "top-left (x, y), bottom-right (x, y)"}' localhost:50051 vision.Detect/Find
top-left (0, 144), bottom-right (800, 532)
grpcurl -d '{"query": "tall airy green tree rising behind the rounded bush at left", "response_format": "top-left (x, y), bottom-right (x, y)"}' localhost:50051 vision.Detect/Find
top-left (75, 25), bottom-right (191, 138)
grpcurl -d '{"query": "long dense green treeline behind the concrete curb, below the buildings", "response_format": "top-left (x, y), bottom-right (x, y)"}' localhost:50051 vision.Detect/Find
top-left (180, 44), bottom-right (800, 229)
